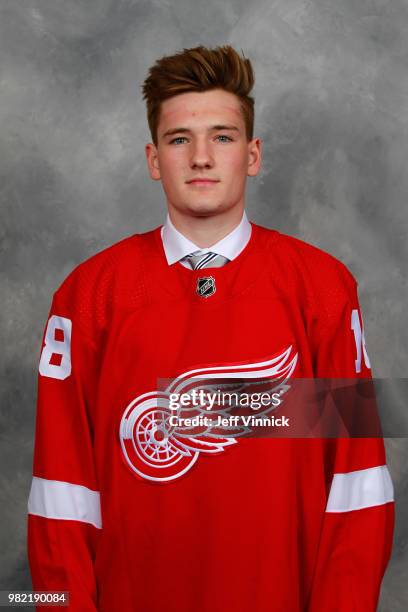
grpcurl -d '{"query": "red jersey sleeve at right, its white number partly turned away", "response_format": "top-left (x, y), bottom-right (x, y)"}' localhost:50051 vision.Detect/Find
top-left (307, 267), bottom-right (394, 612)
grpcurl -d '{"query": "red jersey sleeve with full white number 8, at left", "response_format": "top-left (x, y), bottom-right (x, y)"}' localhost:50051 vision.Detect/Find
top-left (27, 291), bottom-right (102, 612)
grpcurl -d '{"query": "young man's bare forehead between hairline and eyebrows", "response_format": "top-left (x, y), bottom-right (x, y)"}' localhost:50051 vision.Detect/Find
top-left (160, 89), bottom-right (243, 128)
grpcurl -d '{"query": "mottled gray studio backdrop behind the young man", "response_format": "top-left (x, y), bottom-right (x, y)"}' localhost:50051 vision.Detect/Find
top-left (0, 0), bottom-right (408, 612)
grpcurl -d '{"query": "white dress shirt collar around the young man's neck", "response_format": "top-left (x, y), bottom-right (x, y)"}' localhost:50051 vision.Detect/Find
top-left (160, 210), bottom-right (252, 268)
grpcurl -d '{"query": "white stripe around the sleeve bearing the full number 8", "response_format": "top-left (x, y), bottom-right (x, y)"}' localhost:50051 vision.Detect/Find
top-left (28, 476), bottom-right (102, 529)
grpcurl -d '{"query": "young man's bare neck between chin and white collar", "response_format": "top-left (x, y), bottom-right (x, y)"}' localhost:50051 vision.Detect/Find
top-left (169, 205), bottom-right (244, 248)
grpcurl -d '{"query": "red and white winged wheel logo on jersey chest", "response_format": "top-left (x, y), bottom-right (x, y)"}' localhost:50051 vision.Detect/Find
top-left (119, 346), bottom-right (298, 483)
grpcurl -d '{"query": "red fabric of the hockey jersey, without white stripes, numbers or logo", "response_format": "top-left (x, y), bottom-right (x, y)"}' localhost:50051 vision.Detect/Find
top-left (28, 223), bottom-right (394, 612)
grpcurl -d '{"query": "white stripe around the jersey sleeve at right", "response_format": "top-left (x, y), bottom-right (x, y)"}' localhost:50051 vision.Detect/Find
top-left (326, 465), bottom-right (394, 512)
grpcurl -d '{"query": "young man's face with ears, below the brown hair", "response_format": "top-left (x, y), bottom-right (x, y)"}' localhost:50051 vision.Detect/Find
top-left (146, 89), bottom-right (261, 216)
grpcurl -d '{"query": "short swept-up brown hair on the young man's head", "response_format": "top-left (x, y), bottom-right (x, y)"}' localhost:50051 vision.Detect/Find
top-left (142, 45), bottom-right (255, 146)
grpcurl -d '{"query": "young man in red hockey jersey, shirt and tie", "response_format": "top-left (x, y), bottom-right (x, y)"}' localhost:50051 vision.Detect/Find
top-left (28, 46), bottom-right (394, 612)
